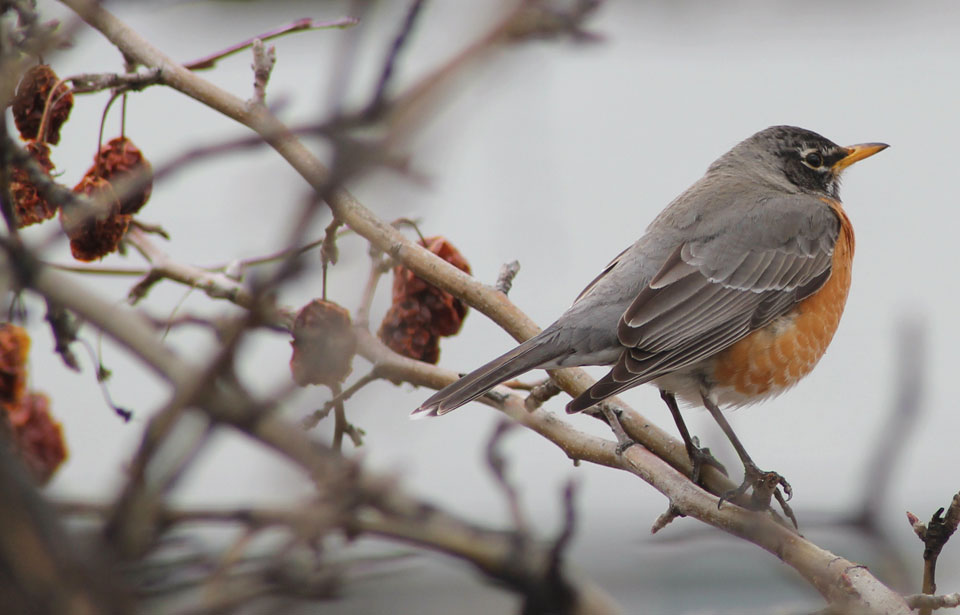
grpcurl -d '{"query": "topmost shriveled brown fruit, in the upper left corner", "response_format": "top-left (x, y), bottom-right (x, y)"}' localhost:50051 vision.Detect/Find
top-left (13, 64), bottom-right (73, 145)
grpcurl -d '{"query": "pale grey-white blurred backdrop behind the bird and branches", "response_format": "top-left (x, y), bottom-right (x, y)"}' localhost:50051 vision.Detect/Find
top-left (22, 1), bottom-right (960, 613)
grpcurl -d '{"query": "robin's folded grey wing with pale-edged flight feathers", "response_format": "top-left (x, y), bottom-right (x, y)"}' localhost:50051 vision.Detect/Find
top-left (567, 196), bottom-right (840, 412)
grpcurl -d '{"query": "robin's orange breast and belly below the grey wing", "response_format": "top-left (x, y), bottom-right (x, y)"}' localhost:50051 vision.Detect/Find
top-left (713, 201), bottom-right (854, 398)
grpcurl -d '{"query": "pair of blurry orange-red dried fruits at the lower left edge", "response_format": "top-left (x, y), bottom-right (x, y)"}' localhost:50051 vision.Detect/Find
top-left (0, 323), bottom-right (67, 484)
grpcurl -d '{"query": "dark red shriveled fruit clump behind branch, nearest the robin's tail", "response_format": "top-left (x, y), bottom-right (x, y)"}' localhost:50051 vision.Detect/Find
top-left (379, 237), bottom-right (470, 363)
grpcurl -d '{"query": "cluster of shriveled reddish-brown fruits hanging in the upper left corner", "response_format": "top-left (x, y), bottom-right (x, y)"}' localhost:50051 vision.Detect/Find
top-left (11, 65), bottom-right (153, 261)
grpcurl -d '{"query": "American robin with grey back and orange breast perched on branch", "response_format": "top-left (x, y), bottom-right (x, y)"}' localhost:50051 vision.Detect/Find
top-left (414, 126), bottom-right (887, 510)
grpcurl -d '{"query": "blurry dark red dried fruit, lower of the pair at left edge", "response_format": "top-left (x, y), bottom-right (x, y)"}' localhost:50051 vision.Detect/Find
top-left (3, 393), bottom-right (67, 484)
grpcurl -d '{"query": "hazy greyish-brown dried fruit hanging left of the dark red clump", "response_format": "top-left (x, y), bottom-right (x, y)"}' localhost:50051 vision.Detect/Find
top-left (290, 299), bottom-right (357, 387)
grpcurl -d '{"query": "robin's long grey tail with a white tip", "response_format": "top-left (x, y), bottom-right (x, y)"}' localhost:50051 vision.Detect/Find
top-left (412, 332), bottom-right (568, 417)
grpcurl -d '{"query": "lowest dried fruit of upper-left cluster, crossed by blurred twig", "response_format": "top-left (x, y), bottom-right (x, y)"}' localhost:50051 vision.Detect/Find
top-left (60, 175), bottom-right (131, 261)
